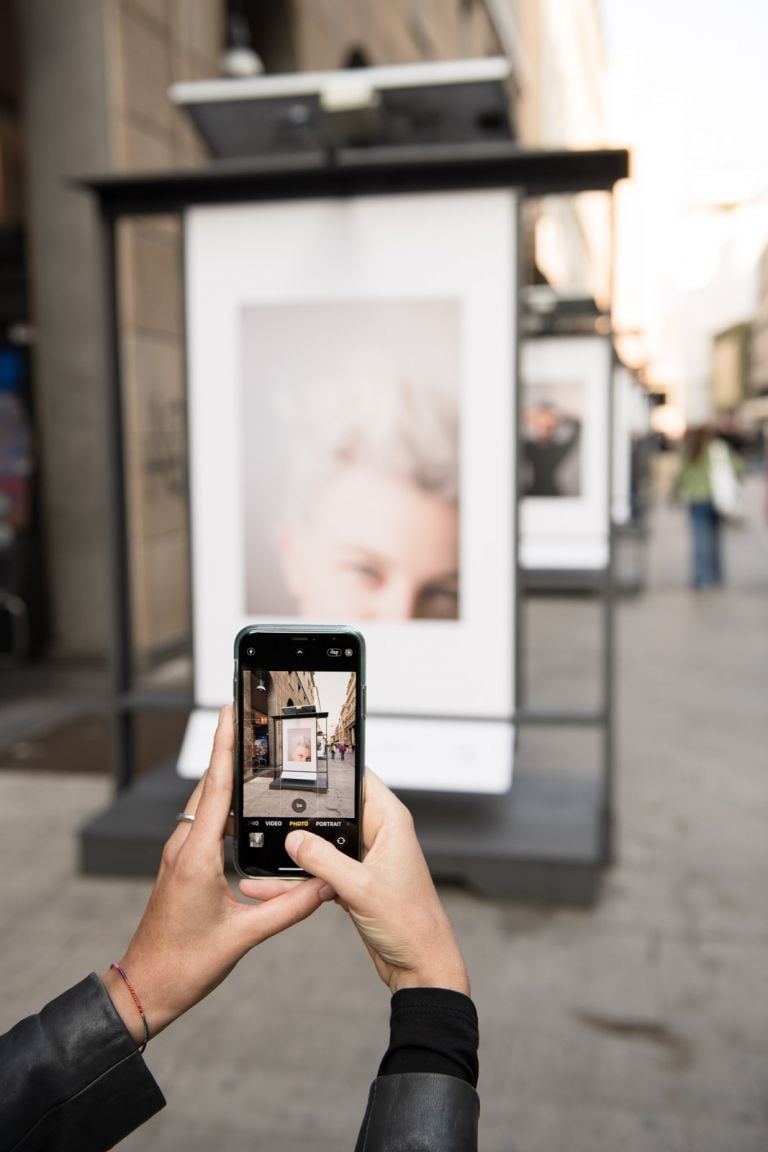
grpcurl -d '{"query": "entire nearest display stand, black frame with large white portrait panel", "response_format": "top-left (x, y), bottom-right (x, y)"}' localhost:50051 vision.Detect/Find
top-left (81, 145), bottom-right (628, 903)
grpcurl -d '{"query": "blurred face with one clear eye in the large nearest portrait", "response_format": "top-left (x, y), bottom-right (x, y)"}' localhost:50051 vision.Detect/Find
top-left (282, 464), bottom-right (458, 620)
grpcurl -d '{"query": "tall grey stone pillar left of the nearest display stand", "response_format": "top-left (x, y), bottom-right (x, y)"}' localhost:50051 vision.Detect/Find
top-left (17, 0), bottom-right (115, 655)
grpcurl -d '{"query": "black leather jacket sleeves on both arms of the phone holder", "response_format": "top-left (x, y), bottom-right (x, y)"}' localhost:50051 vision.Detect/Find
top-left (0, 975), bottom-right (480, 1152)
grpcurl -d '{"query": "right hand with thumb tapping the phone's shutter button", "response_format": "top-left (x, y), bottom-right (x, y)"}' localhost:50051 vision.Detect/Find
top-left (239, 771), bottom-right (470, 995)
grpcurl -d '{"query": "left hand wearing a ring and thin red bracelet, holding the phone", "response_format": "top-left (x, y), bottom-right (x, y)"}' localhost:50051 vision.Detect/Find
top-left (101, 707), bottom-right (334, 1041)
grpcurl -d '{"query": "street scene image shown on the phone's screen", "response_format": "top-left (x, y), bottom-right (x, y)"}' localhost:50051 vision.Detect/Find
top-left (243, 668), bottom-right (357, 820)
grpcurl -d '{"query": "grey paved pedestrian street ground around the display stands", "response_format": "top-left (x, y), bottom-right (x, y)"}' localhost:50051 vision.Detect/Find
top-left (0, 463), bottom-right (768, 1152)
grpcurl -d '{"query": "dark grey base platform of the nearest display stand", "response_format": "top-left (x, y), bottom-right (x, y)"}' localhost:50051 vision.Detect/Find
top-left (81, 763), bottom-right (602, 907)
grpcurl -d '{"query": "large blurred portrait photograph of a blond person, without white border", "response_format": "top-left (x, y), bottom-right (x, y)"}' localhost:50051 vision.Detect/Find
top-left (239, 297), bottom-right (462, 621)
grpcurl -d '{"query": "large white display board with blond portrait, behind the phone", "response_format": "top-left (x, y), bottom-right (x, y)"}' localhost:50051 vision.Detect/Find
top-left (182, 191), bottom-right (517, 791)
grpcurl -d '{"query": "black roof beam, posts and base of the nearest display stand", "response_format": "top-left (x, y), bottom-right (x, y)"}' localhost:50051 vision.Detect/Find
top-left (77, 143), bottom-right (629, 903)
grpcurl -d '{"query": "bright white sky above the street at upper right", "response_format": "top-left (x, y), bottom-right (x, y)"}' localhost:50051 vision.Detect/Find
top-left (600, 0), bottom-right (768, 407)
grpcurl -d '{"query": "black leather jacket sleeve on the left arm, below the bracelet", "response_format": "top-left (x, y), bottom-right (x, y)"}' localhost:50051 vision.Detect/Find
top-left (0, 973), bottom-right (166, 1152)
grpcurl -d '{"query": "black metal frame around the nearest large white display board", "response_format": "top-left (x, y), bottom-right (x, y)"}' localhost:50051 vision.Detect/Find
top-left (78, 144), bottom-right (629, 903)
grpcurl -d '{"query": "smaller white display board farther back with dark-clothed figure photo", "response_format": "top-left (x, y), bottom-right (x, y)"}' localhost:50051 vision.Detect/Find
top-left (520, 336), bottom-right (613, 569)
